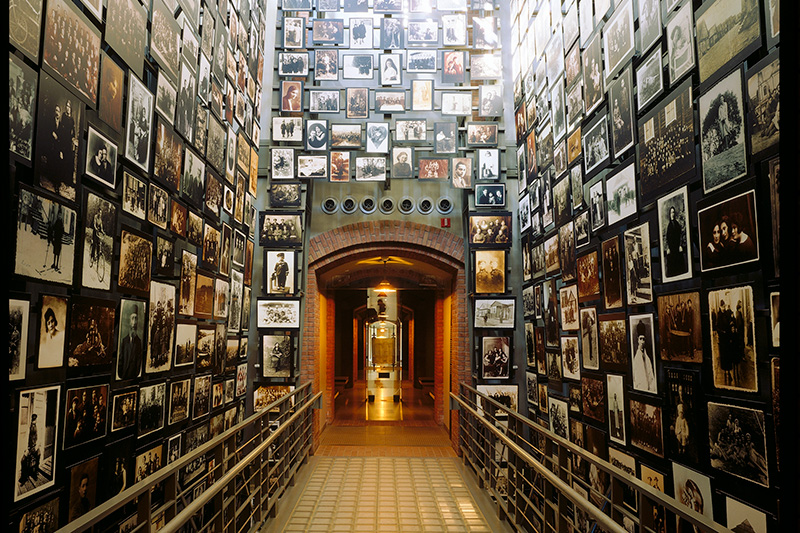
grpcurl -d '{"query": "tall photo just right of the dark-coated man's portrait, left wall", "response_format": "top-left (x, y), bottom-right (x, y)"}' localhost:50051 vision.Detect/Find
top-left (144, 281), bottom-right (175, 374)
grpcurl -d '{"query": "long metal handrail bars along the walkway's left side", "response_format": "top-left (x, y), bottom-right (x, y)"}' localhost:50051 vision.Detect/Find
top-left (58, 382), bottom-right (322, 533)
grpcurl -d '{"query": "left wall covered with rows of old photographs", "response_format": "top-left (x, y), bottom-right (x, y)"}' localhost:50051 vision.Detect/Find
top-left (4, 0), bottom-right (266, 531)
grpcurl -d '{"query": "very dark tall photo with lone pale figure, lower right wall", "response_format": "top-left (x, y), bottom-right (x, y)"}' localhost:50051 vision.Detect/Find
top-left (665, 368), bottom-right (706, 464)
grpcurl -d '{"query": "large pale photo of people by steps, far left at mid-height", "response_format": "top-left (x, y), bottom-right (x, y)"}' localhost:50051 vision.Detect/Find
top-left (14, 187), bottom-right (80, 285)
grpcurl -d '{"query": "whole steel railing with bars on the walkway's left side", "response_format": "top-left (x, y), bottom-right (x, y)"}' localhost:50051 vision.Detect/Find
top-left (58, 383), bottom-right (322, 533)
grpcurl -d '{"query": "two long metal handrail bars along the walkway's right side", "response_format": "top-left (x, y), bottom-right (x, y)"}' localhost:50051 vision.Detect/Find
top-left (450, 383), bottom-right (729, 533)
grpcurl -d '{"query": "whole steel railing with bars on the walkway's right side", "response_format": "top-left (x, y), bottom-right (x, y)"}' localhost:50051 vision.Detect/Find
top-left (450, 384), bottom-right (729, 533)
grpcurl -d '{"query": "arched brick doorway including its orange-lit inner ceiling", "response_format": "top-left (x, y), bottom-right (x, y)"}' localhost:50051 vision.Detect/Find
top-left (300, 221), bottom-right (470, 448)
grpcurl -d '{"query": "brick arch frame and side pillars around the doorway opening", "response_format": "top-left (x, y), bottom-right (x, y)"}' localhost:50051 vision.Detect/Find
top-left (300, 220), bottom-right (471, 446)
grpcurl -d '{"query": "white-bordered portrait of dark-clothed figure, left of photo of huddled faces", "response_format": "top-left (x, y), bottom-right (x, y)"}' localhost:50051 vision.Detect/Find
top-left (648, 186), bottom-right (702, 283)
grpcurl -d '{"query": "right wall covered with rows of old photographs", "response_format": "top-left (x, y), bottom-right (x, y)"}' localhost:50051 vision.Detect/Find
top-left (512, 0), bottom-right (781, 531)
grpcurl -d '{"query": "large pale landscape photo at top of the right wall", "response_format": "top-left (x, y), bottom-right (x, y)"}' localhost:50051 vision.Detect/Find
top-left (690, 0), bottom-right (761, 84)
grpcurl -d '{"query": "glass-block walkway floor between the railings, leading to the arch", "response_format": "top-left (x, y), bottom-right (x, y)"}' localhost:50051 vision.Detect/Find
top-left (262, 425), bottom-right (511, 533)
